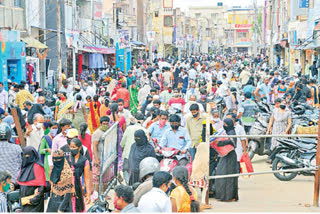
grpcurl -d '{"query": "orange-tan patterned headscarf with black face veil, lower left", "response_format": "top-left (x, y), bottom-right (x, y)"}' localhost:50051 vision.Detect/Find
top-left (50, 149), bottom-right (75, 196)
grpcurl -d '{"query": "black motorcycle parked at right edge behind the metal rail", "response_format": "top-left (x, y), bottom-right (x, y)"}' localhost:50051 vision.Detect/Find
top-left (270, 138), bottom-right (317, 181)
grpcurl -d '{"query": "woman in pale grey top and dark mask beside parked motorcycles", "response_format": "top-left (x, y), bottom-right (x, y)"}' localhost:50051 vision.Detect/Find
top-left (267, 100), bottom-right (292, 151)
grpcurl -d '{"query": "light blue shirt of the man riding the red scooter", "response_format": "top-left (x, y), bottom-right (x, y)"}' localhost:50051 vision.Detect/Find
top-left (159, 127), bottom-right (191, 150)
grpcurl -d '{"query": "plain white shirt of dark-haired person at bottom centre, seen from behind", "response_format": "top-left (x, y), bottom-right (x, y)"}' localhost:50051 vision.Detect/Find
top-left (137, 187), bottom-right (172, 213)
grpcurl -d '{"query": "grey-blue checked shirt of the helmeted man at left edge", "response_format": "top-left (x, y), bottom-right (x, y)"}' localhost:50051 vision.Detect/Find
top-left (0, 141), bottom-right (22, 182)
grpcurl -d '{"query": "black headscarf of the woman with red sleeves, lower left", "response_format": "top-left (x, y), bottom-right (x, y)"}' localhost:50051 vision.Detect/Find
top-left (17, 146), bottom-right (42, 182)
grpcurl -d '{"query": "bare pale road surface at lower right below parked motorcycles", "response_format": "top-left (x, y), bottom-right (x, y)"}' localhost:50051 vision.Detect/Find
top-left (206, 156), bottom-right (320, 212)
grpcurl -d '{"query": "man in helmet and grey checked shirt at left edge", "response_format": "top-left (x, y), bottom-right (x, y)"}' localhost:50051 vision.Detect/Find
top-left (0, 123), bottom-right (22, 182)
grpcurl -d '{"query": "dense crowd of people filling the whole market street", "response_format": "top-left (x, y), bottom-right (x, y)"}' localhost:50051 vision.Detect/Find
top-left (0, 54), bottom-right (320, 212)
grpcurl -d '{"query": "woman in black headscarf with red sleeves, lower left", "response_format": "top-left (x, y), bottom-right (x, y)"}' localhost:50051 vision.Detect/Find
top-left (12, 146), bottom-right (47, 213)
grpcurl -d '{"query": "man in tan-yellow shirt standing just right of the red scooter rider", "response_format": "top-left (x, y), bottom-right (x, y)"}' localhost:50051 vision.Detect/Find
top-left (186, 103), bottom-right (206, 160)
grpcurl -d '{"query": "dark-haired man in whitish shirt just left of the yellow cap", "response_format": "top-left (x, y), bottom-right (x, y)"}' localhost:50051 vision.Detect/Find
top-left (52, 118), bottom-right (72, 153)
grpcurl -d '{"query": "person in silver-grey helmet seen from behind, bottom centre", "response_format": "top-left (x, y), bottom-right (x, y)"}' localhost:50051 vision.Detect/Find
top-left (133, 157), bottom-right (160, 207)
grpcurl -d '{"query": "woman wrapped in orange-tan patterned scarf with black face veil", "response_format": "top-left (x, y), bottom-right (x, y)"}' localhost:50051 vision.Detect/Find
top-left (47, 149), bottom-right (76, 212)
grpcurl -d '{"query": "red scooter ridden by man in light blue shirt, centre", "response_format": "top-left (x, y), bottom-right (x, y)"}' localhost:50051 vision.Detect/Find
top-left (152, 138), bottom-right (192, 175)
